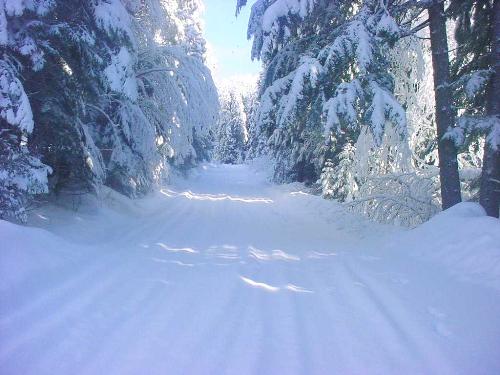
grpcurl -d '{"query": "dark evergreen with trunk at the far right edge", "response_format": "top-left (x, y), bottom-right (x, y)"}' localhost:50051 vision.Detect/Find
top-left (448, 0), bottom-right (500, 217)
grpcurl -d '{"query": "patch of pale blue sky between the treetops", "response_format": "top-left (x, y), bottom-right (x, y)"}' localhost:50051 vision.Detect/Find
top-left (204, 0), bottom-right (260, 79)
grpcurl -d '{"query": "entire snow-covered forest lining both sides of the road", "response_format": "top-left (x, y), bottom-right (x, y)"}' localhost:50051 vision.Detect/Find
top-left (0, 0), bottom-right (500, 226)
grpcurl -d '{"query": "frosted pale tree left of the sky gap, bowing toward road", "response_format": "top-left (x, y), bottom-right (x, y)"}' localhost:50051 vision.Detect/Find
top-left (135, 0), bottom-right (219, 168)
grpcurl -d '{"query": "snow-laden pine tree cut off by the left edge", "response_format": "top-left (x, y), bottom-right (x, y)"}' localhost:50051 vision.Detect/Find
top-left (0, 0), bottom-right (51, 221)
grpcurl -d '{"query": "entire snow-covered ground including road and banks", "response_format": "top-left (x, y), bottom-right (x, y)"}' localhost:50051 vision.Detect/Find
top-left (0, 164), bottom-right (500, 375)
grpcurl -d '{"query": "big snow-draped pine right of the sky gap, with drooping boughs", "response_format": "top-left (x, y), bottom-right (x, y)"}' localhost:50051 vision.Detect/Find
top-left (239, 0), bottom-right (406, 182)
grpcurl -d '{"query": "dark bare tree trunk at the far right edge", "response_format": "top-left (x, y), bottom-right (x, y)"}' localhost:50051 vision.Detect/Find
top-left (479, 0), bottom-right (500, 217)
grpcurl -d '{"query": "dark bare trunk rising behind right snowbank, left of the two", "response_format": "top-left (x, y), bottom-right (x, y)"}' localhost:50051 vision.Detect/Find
top-left (429, 1), bottom-right (462, 210)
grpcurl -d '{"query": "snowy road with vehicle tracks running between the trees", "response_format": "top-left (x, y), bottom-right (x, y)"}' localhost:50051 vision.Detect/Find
top-left (0, 166), bottom-right (498, 375)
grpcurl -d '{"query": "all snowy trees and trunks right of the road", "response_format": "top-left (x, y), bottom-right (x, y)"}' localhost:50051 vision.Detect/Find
top-left (236, 0), bottom-right (500, 225)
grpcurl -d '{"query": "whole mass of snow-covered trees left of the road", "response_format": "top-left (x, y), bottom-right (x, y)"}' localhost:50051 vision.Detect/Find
top-left (0, 0), bottom-right (218, 220)
